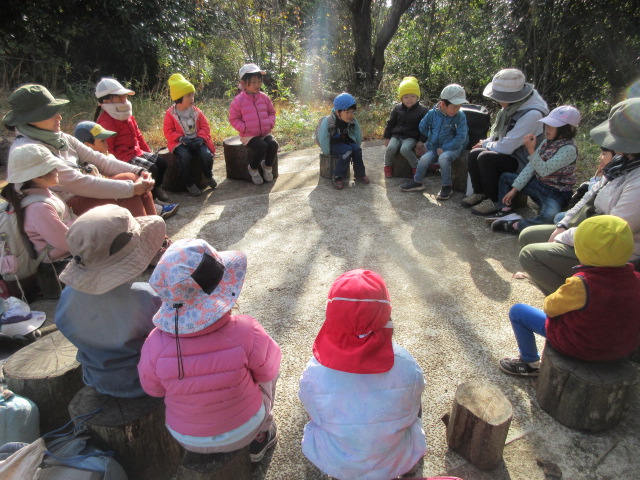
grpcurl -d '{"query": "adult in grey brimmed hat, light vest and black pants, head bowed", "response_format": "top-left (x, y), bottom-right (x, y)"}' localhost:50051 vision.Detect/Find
top-left (462, 68), bottom-right (549, 215)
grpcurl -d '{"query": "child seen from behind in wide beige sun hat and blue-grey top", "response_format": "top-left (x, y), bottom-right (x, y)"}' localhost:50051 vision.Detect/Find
top-left (56, 205), bottom-right (166, 398)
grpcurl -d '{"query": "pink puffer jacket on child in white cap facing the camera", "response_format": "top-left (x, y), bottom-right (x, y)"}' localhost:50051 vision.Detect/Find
top-left (229, 91), bottom-right (276, 137)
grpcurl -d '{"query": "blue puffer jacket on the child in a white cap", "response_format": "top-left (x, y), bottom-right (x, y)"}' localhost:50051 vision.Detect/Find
top-left (420, 104), bottom-right (469, 152)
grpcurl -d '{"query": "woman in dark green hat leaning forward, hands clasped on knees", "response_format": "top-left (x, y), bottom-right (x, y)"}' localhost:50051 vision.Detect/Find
top-left (2, 84), bottom-right (156, 216)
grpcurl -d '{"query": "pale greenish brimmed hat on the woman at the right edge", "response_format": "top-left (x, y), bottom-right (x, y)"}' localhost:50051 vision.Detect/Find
top-left (589, 98), bottom-right (640, 153)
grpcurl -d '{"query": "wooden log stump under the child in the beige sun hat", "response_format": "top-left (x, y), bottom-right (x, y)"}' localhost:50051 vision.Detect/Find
top-left (69, 386), bottom-right (181, 480)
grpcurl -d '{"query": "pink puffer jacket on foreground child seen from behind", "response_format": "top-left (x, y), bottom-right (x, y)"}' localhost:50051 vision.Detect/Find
top-left (138, 313), bottom-right (282, 437)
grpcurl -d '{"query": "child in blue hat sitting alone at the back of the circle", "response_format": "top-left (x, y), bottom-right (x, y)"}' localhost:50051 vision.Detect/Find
top-left (318, 92), bottom-right (369, 190)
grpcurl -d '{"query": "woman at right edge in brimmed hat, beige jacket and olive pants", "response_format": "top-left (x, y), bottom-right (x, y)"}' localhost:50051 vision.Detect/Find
top-left (519, 98), bottom-right (640, 295)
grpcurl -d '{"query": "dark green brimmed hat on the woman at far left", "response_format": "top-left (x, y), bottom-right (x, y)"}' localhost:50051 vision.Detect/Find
top-left (2, 83), bottom-right (69, 127)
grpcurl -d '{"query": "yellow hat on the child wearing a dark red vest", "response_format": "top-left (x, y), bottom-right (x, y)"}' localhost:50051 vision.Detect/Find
top-left (573, 215), bottom-right (635, 267)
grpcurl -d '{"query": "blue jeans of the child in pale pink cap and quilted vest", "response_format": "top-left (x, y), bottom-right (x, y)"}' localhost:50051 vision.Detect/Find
top-left (498, 172), bottom-right (571, 230)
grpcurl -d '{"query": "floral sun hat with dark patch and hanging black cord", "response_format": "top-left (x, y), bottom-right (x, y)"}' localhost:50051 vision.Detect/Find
top-left (149, 239), bottom-right (247, 335)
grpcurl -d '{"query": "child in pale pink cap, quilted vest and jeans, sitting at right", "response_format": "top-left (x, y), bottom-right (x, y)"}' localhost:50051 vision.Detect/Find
top-left (491, 105), bottom-right (580, 234)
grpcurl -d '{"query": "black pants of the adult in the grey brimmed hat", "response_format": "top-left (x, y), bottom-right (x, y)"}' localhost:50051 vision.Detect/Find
top-left (468, 148), bottom-right (518, 202)
